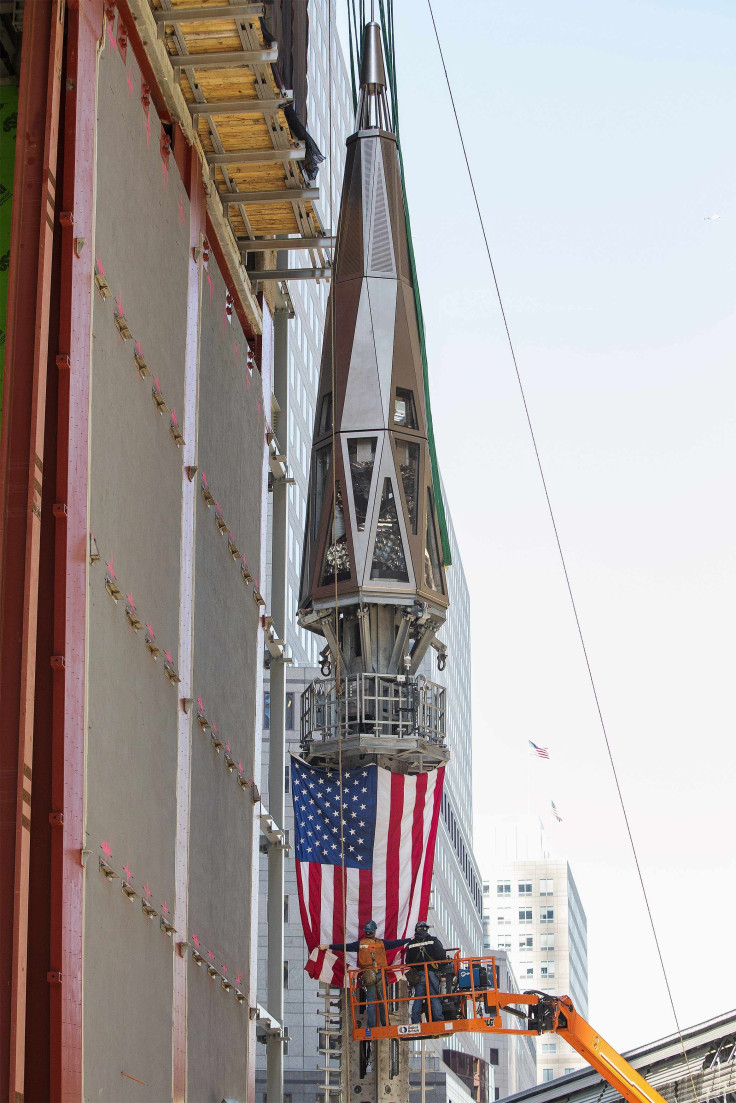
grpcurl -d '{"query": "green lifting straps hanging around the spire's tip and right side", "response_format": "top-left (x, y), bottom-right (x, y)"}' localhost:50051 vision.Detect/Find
top-left (348, 0), bottom-right (452, 567)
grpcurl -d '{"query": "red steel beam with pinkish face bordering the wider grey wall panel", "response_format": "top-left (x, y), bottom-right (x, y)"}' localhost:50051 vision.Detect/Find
top-left (50, 0), bottom-right (104, 1103)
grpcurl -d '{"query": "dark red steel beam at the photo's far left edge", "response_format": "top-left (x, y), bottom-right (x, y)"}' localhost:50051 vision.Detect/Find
top-left (0, 3), bottom-right (64, 1100)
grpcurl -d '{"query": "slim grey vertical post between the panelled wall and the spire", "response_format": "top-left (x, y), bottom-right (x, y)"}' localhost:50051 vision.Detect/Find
top-left (266, 310), bottom-right (289, 1103)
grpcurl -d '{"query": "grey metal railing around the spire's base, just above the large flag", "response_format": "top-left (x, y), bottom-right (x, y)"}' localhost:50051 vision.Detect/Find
top-left (301, 674), bottom-right (445, 746)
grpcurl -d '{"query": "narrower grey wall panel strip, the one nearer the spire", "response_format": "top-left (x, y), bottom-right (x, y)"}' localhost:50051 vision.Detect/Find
top-left (189, 245), bottom-right (265, 1089)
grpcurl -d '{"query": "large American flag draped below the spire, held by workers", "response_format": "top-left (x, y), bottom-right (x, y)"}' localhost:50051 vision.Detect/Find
top-left (291, 754), bottom-right (445, 987)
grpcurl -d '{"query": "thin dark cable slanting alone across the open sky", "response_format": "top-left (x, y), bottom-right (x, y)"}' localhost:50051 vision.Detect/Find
top-left (427, 0), bottom-right (697, 1085)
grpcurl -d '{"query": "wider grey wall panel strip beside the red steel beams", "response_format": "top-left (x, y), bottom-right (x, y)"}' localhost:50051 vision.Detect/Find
top-left (84, 27), bottom-right (189, 1100)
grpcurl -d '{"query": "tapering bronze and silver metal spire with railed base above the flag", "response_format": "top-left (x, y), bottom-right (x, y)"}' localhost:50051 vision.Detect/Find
top-left (299, 15), bottom-right (448, 772)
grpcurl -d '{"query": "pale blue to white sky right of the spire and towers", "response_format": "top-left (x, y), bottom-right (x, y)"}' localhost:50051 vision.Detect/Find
top-left (339, 0), bottom-right (736, 1050)
